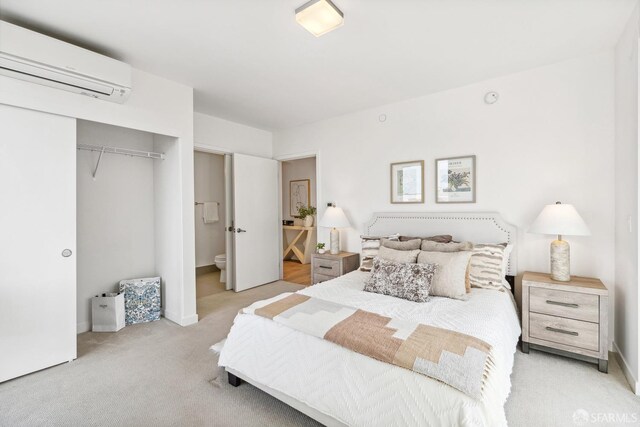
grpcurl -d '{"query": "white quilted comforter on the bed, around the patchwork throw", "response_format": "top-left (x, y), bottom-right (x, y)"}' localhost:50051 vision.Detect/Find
top-left (218, 271), bottom-right (520, 426)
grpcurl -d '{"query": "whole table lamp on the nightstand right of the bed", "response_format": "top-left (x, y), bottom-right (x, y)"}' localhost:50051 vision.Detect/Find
top-left (529, 202), bottom-right (591, 282)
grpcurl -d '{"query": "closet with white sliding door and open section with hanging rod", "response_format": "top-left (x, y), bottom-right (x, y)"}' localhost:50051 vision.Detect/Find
top-left (0, 105), bottom-right (180, 382)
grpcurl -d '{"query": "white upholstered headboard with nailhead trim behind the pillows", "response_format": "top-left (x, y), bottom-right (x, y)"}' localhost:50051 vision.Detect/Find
top-left (364, 212), bottom-right (518, 276)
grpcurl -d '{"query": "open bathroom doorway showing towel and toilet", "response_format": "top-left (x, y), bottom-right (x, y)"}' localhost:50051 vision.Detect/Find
top-left (193, 151), bottom-right (228, 300)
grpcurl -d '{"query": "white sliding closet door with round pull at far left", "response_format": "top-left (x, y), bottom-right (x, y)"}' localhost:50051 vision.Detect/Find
top-left (0, 105), bottom-right (77, 382)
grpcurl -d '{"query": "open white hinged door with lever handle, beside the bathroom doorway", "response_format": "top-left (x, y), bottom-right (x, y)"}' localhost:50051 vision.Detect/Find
top-left (229, 154), bottom-right (281, 292)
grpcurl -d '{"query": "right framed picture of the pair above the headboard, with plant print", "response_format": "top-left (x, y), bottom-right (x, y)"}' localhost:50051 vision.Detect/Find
top-left (435, 155), bottom-right (477, 203)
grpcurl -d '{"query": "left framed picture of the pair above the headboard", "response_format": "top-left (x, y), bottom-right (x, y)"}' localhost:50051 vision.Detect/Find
top-left (390, 160), bottom-right (424, 204)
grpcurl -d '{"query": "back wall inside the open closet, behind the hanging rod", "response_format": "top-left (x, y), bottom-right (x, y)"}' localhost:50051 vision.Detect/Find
top-left (76, 120), bottom-right (156, 333)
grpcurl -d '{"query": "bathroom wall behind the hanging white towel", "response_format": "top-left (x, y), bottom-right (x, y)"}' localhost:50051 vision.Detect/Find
top-left (194, 151), bottom-right (226, 267)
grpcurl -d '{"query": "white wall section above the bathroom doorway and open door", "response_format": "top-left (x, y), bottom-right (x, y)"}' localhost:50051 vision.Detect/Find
top-left (193, 113), bottom-right (272, 157)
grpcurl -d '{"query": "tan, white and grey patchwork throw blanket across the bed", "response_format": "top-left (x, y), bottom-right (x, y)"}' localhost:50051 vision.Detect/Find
top-left (240, 293), bottom-right (493, 399)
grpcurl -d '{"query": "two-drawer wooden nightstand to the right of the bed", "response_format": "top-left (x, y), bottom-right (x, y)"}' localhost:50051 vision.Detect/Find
top-left (522, 272), bottom-right (609, 372)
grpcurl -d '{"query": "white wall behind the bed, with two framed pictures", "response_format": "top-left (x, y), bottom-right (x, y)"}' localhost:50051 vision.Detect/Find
top-left (274, 52), bottom-right (615, 344)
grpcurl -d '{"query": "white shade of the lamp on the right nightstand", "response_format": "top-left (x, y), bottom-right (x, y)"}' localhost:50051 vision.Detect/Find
top-left (529, 203), bottom-right (591, 236)
